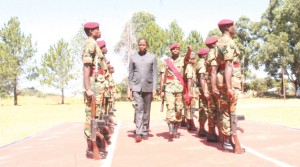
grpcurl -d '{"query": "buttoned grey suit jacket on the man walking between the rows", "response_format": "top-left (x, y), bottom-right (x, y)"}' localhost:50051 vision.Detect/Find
top-left (128, 52), bottom-right (158, 92)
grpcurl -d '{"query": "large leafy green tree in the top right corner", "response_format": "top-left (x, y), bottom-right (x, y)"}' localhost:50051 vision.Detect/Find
top-left (253, 0), bottom-right (300, 92)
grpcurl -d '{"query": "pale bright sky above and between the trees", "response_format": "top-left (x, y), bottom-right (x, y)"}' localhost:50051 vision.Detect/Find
top-left (0, 0), bottom-right (269, 96)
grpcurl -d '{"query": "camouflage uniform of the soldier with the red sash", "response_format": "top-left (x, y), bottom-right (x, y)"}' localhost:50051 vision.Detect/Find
top-left (161, 56), bottom-right (184, 123)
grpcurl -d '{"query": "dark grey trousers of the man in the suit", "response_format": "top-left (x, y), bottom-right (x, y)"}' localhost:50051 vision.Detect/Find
top-left (133, 92), bottom-right (152, 135)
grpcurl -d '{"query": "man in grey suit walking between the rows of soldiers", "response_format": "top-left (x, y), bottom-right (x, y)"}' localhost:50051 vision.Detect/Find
top-left (128, 38), bottom-right (157, 142)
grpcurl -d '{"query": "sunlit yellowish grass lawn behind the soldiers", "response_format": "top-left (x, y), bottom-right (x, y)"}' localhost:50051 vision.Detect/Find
top-left (0, 96), bottom-right (300, 147)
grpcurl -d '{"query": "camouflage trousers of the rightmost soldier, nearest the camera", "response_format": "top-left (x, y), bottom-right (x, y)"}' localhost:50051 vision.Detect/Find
top-left (220, 90), bottom-right (238, 136)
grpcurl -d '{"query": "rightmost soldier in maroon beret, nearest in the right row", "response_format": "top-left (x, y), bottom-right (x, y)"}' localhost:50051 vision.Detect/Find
top-left (217, 19), bottom-right (245, 154)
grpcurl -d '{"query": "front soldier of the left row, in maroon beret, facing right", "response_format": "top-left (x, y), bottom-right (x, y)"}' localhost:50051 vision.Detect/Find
top-left (82, 22), bottom-right (106, 158)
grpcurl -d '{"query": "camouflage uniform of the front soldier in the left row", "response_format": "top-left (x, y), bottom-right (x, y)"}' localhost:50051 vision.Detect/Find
top-left (82, 37), bottom-right (104, 138)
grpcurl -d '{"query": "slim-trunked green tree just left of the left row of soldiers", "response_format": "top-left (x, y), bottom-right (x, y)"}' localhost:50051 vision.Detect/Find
top-left (39, 39), bottom-right (77, 104)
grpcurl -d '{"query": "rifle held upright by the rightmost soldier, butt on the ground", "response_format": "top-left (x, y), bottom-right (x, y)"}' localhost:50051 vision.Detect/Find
top-left (229, 96), bottom-right (245, 154)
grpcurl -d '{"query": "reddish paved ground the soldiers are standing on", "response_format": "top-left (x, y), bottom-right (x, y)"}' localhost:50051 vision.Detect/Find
top-left (0, 120), bottom-right (300, 167)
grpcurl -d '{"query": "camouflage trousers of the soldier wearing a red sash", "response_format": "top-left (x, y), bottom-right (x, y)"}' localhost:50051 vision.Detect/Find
top-left (165, 92), bottom-right (184, 123)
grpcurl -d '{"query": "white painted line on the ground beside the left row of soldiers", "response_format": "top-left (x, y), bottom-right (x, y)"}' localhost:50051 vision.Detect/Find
top-left (101, 121), bottom-right (121, 167)
